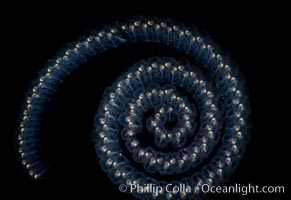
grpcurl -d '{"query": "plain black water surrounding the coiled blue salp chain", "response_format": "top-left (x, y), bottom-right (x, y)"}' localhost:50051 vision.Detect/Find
top-left (0, 3), bottom-right (290, 199)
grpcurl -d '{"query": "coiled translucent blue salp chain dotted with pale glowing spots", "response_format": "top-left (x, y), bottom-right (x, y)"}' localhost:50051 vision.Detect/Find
top-left (18, 17), bottom-right (250, 199)
